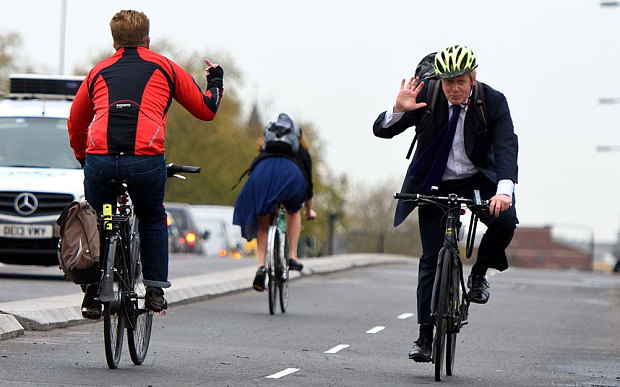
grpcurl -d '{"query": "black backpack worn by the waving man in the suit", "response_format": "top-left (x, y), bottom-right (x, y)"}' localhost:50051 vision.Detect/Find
top-left (407, 52), bottom-right (488, 159)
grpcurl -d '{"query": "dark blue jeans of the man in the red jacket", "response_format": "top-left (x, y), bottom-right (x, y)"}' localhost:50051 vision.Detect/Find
top-left (84, 154), bottom-right (170, 288)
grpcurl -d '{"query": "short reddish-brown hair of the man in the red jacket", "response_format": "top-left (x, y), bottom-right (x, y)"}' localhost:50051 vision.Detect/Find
top-left (110, 10), bottom-right (149, 49)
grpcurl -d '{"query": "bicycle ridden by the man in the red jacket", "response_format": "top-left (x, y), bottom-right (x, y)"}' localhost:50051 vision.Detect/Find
top-left (99, 163), bottom-right (200, 369)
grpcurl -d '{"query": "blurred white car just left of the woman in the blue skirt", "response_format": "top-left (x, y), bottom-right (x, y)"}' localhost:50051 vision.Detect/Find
top-left (192, 204), bottom-right (245, 258)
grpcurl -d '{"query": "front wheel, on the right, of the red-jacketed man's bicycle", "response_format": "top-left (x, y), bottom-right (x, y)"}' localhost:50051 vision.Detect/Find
top-left (127, 224), bottom-right (153, 365)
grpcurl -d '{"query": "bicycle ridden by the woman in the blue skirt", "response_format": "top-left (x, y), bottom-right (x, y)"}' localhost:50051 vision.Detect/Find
top-left (265, 203), bottom-right (289, 314)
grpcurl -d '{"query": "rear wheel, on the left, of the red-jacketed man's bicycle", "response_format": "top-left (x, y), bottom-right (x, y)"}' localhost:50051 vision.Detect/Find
top-left (103, 239), bottom-right (125, 369)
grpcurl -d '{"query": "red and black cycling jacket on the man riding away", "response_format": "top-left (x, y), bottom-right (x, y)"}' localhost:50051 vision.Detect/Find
top-left (67, 47), bottom-right (223, 159)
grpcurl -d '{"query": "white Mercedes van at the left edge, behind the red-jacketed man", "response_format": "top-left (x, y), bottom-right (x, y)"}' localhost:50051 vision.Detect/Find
top-left (0, 74), bottom-right (84, 265)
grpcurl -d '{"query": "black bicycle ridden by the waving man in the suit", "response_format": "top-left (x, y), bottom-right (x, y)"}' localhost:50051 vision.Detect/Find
top-left (394, 190), bottom-right (489, 381)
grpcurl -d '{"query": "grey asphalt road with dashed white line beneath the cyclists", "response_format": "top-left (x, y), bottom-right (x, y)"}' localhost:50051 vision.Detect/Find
top-left (0, 262), bottom-right (620, 386)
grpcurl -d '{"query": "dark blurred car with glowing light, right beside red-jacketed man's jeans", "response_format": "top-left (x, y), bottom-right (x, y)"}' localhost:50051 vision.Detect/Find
top-left (164, 202), bottom-right (207, 254)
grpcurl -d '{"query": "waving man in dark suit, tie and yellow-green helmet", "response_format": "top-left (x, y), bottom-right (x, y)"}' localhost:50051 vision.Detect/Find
top-left (373, 44), bottom-right (518, 362)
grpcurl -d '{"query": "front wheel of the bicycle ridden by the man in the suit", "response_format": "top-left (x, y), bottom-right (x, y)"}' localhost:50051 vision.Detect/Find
top-left (433, 249), bottom-right (450, 382)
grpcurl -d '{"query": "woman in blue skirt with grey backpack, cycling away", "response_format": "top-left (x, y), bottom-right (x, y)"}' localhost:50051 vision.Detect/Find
top-left (233, 113), bottom-right (316, 292)
